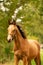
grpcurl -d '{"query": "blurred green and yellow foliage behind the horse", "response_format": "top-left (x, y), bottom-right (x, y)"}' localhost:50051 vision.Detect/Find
top-left (0, 0), bottom-right (43, 65)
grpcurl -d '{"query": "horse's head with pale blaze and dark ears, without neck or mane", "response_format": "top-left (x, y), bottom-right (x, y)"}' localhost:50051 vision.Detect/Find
top-left (7, 20), bottom-right (17, 42)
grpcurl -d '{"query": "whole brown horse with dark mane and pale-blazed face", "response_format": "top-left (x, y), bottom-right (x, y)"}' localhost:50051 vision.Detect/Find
top-left (7, 21), bottom-right (41, 65)
